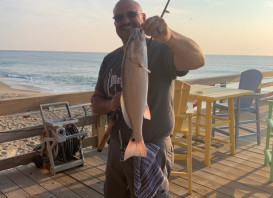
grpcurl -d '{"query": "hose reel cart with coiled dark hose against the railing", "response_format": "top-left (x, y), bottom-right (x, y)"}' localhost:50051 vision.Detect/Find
top-left (34, 102), bottom-right (87, 174)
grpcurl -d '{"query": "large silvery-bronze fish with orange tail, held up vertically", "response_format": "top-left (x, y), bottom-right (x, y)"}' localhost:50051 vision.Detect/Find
top-left (121, 28), bottom-right (151, 160)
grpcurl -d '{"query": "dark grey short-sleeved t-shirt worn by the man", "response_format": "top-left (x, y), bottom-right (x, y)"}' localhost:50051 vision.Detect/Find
top-left (95, 40), bottom-right (188, 142)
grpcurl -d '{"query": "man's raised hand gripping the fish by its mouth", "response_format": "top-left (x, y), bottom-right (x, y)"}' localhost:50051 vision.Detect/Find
top-left (141, 16), bottom-right (172, 43)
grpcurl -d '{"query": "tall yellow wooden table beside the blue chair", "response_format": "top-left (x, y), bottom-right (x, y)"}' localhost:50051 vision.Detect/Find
top-left (189, 84), bottom-right (254, 166)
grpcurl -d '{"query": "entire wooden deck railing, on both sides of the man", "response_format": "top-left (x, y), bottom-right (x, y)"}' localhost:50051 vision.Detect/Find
top-left (0, 71), bottom-right (273, 171)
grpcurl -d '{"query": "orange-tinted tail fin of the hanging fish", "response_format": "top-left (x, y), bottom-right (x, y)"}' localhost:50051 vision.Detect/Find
top-left (124, 138), bottom-right (147, 161)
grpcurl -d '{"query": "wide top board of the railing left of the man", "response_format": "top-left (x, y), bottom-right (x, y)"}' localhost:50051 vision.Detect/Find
top-left (0, 91), bottom-right (93, 116)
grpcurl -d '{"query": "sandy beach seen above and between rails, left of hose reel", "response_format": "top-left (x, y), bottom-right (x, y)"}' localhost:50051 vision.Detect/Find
top-left (0, 82), bottom-right (48, 159)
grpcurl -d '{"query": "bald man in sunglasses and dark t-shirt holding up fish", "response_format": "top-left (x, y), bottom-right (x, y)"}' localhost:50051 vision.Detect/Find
top-left (91, 0), bottom-right (204, 198)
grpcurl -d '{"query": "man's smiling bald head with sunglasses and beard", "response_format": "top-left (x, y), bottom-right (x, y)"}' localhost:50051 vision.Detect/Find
top-left (114, 1), bottom-right (146, 45)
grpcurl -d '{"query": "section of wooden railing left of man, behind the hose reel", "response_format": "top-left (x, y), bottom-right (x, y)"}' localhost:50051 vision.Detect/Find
top-left (0, 91), bottom-right (106, 171)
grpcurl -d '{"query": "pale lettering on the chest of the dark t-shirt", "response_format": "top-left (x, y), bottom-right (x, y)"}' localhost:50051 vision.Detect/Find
top-left (107, 69), bottom-right (121, 97)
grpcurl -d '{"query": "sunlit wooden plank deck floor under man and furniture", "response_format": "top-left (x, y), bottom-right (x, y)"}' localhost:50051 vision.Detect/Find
top-left (0, 101), bottom-right (273, 198)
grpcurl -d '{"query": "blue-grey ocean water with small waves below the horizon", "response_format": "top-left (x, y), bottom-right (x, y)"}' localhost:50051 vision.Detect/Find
top-left (0, 50), bottom-right (273, 93)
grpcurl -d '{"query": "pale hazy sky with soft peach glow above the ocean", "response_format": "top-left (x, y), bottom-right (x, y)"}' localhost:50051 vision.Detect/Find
top-left (0, 0), bottom-right (273, 56)
